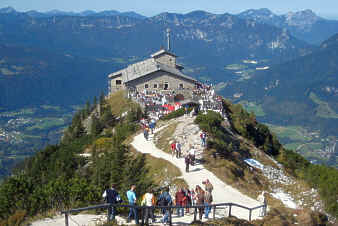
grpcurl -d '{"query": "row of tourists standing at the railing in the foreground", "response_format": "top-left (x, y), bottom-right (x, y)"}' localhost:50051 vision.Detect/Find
top-left (102, 179), bottom-right (213, 224)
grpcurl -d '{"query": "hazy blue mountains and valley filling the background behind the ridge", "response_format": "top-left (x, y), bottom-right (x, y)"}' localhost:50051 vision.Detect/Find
top-left (0, 6), bottom-right (338, 175)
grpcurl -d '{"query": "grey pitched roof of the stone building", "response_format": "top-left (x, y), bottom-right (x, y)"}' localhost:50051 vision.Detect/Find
top-left (108, 50), bottom-right (198, 83)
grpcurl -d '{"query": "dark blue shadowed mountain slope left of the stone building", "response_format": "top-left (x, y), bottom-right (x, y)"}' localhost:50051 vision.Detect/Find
top-left (0, 45), bottom-right (112, 108)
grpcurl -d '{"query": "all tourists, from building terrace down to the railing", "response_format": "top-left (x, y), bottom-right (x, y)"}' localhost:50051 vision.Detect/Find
top-left (102, 85), bottom-right (223, 224)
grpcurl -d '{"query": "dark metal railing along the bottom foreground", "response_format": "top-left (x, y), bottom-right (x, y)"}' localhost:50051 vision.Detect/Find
top-left (61, 203), bottom-right (267, 226)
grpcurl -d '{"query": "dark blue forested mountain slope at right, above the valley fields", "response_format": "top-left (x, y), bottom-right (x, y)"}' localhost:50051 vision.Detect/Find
top-left (222, 35), bottom-right (338, 136)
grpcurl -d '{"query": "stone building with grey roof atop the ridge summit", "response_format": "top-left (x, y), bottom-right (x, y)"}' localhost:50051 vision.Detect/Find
top-left (109, 49), bottom-right (199, 95)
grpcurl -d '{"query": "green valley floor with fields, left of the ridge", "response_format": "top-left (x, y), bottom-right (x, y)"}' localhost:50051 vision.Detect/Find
top-left (0, 105), bottom-right (79, 178)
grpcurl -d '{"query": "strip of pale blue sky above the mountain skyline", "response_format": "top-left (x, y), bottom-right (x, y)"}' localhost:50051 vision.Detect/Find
top-left (0, 0), bottom-right (338, 18)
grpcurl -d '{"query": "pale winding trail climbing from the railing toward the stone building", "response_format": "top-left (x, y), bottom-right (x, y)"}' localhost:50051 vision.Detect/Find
top-left (131, 116), bottom-right (262, 223)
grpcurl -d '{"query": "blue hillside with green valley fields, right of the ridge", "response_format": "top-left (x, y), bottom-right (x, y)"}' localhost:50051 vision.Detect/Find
top-left (219, 35), bottom-right (338, 167)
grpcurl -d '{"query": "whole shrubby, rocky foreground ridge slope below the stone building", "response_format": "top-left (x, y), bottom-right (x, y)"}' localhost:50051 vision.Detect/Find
top-left (0, 93), bottom-right (338, 225)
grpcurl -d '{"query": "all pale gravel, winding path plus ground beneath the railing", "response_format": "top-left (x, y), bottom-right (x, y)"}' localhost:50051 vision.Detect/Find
top-left (32, 117), bottom-right (261, 226)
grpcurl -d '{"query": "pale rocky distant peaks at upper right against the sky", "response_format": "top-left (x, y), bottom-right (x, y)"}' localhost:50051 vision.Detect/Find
top-left (238, 9), bottom-right (338, 45)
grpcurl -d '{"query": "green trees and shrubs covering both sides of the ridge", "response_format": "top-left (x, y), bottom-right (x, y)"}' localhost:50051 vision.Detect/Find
top-left (0, 94), bottom-right (338, 225)
